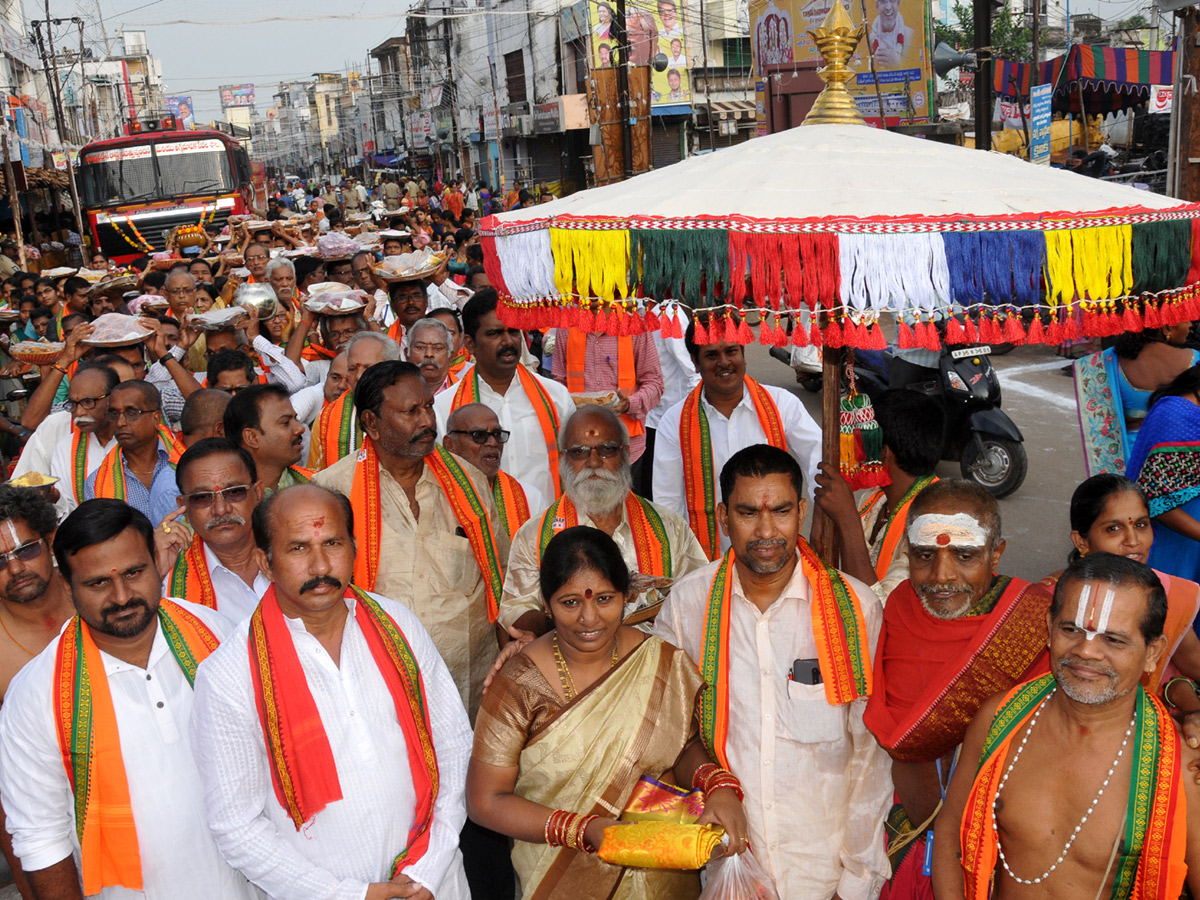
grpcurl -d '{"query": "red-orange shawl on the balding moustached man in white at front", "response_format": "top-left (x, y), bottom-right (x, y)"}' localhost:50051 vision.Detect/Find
top-left (247, 584), bottom-right (438, 877)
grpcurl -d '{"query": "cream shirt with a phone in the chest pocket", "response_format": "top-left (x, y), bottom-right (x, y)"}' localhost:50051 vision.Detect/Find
top-left (654, 563), bottom-right (892, 900)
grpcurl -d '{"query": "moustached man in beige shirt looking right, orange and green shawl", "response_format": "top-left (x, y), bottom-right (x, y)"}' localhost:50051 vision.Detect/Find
top-left (314, 360), bottom-right (509, 719)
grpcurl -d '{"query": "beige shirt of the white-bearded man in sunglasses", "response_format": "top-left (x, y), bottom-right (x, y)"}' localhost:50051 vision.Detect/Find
top-left (500, 494), bottom-right (708, 628)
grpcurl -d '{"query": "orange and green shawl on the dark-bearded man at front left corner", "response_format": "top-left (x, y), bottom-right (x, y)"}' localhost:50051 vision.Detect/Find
top-left (54, 599), bottom-right (220, 896)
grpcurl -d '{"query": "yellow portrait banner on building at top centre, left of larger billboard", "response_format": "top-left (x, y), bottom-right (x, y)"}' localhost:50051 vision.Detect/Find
top-left (588, 0), bottom-right (691, 108)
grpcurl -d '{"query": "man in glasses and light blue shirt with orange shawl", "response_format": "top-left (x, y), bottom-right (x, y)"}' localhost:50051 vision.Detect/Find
top-left (84, 382), bottom-right (175, 522)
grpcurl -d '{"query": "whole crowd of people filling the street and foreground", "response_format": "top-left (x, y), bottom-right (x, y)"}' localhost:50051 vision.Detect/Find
top-left (0, 192), bottom-right (1200, 900)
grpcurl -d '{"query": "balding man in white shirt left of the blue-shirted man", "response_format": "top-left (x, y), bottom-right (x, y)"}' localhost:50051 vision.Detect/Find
top-left (50, 362), bottom-right (119, 518)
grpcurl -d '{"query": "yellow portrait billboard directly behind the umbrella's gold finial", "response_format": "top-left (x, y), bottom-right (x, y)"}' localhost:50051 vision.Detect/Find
top-left (750, 0), bottom-right (932, 125)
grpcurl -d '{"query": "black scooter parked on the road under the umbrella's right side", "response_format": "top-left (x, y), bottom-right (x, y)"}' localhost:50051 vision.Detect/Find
top-left (772, 344), bottom-right (1028, 497)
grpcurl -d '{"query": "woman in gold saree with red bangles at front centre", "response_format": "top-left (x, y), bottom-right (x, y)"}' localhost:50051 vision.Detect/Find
top-left (467, 527), bottom-right (749, 900)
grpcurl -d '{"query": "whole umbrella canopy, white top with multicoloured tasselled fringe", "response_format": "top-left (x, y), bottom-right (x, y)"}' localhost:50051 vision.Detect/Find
top-left (482, 125), bottom-right (1200, 347)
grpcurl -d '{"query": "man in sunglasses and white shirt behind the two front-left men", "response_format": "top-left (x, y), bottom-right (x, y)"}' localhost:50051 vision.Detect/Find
top-left (162, 438), bottom-right (269, 622)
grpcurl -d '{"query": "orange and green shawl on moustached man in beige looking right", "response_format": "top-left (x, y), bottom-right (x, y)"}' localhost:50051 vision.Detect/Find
top-left (350, 440), bottom-right (504, 622)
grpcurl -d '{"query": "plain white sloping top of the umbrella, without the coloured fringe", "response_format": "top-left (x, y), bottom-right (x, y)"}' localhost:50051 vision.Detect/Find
top-left (494, 125), bottom-right (1186, 229)
